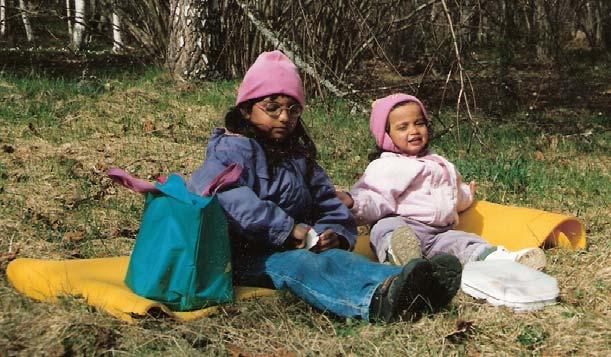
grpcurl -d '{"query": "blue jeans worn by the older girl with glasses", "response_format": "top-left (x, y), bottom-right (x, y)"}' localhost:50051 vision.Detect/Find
top-left (234, 249), bottom-right (402, 320)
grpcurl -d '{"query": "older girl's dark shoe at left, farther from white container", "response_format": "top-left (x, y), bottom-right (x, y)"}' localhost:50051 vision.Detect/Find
top-left (369, 259), bottom-right (433, 322)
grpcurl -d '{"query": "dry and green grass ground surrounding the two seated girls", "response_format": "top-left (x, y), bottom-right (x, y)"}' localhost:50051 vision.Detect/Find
top-left (0, 68), bottom-right (611, 355)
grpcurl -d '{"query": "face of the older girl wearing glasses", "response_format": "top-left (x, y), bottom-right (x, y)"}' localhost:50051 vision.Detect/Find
top-left (242, 95), bottom-right (303, 141)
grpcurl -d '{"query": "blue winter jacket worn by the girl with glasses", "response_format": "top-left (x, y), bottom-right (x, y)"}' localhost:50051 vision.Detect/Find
top-left (188, 128), bottom-right (356, 250)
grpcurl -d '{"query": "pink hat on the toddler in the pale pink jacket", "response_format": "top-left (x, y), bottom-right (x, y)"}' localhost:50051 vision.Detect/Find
top-left (369, 93), bottom-right (428, 153)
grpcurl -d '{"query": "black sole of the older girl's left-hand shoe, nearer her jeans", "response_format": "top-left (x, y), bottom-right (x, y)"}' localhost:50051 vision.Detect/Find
top-left (385, 259), bottom-right (433, 322)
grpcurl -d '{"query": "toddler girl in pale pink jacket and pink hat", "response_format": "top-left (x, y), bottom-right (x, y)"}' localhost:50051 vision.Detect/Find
top-left (338, 94), bottom-right (545, 269)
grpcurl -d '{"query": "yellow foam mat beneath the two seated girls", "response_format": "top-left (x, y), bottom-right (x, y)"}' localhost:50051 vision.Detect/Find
top-left (6, 201), bottom-right (586, 322)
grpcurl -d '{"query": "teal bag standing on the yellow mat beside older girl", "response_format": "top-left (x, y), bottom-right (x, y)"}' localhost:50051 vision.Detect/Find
top-left (122, 174), bottom-right (233, 311)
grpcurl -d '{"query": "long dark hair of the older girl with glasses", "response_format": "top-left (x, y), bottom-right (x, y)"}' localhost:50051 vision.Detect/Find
top-left (225, 96), bottom-right (317, 179)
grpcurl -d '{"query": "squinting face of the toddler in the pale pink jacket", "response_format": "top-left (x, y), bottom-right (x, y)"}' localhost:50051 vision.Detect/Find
top-left (388, 103), bottom-right (429, 156)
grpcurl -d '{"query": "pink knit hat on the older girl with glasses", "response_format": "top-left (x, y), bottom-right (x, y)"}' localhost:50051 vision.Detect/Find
top-left (236, 51), bottom-right (305, 107)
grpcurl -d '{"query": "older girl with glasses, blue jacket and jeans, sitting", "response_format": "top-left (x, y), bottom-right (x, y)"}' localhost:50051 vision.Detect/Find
top-left (189, 51), bottom-right (461, 321)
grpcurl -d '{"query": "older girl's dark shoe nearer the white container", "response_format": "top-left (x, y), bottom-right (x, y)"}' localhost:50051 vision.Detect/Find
top-left (430, 253), bottom-right (462, 311)
